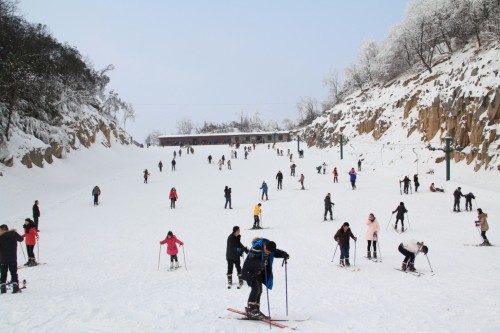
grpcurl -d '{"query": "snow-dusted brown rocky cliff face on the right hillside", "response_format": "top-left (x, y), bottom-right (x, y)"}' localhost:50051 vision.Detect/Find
top-left (303, 45), bottom-right (500, 170)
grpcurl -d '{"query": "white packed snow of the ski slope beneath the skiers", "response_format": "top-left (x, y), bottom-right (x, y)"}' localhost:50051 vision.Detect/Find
top-left (0, 142), bottom-right (500, 333)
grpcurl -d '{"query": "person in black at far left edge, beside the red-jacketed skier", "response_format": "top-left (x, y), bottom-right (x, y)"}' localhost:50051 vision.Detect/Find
top-left (0, 224), bottom-right (24, 294)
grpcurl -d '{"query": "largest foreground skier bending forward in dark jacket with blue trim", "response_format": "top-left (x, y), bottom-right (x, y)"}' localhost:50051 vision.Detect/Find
top-left (242, 238), bottom-right (290, 319)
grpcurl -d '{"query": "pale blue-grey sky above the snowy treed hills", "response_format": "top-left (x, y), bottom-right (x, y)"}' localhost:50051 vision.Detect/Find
top-left (19, 0), bottom-right (409, 141)
